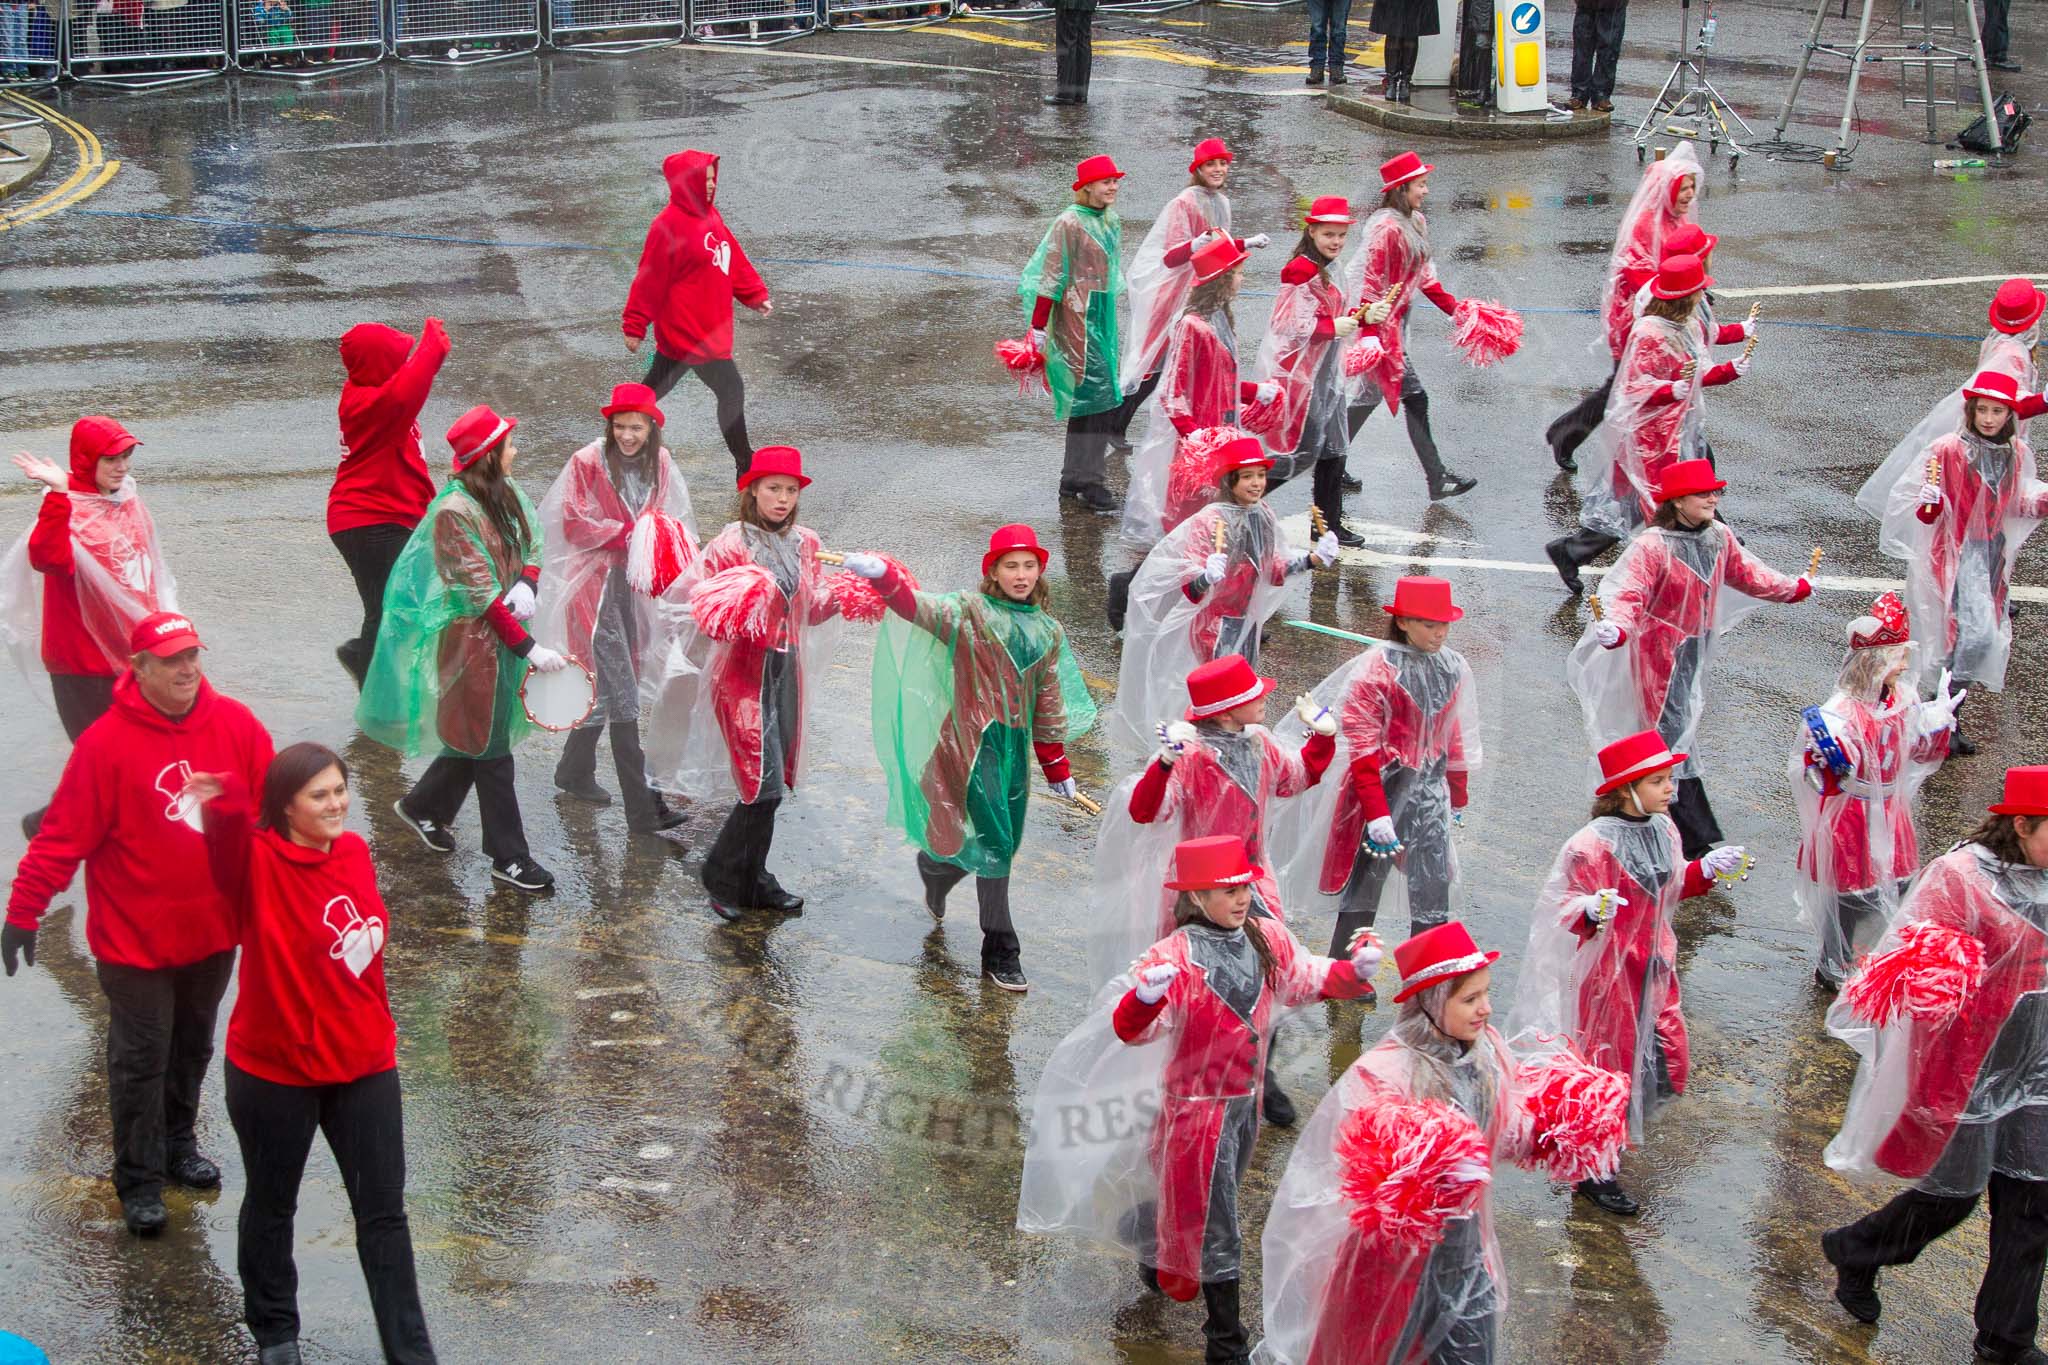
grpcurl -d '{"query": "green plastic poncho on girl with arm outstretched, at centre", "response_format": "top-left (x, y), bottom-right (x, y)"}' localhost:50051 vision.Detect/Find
top-left (872, 591), bottom-right (1096, 878)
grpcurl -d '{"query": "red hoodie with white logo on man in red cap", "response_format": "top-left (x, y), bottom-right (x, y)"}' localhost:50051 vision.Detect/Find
top-left (6, 673), bottom-right (270, 968)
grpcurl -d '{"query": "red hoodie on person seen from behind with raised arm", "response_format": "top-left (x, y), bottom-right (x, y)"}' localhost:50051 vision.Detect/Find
top-left (328, 317), bottom-right (449, 536)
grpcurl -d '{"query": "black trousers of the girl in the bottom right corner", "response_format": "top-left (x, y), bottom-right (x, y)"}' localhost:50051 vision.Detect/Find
top-left (1837, 1171), bottom-right (2048, 1359)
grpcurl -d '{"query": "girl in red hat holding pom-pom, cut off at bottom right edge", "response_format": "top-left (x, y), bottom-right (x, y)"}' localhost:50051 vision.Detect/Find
top-left (1821, 767), bottom-right (2048, 1363)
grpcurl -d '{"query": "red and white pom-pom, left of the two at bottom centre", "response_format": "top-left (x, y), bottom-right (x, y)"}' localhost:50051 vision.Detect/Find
top-left (1337, 1099), bottom-right (1493, 1252)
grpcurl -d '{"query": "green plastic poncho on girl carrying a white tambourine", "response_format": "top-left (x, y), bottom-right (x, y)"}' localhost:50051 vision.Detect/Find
top-left (356, 479), bottom-right (541, 759)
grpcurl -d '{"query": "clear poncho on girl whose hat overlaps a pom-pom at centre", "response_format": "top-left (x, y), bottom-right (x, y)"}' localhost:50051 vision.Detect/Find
top-left (1110, 501), bottom-right (1292, 749)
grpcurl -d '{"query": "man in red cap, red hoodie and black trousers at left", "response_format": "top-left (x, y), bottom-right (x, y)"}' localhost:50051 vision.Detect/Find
top-left (0, 612), bottom-right (270, 1236)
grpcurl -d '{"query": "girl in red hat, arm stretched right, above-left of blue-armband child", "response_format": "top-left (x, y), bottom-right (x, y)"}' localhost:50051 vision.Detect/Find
top-left (1565, 460), bottom-right (1812, 857)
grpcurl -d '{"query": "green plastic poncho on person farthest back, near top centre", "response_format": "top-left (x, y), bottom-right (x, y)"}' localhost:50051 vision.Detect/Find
top-left (1018, 205), bottom-right (1124, 420)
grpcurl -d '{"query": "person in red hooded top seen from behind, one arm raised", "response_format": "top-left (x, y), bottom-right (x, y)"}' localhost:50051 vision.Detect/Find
top-left (328, 317), bottom-right (449, 688)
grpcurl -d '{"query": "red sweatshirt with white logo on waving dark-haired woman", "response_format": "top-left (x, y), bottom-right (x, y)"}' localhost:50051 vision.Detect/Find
top-left (205, 802), bottom-right (397, 1085)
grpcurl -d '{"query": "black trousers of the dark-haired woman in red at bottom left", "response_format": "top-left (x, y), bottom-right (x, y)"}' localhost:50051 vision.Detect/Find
top-left (227, 1062), bottom-right (434, 1365)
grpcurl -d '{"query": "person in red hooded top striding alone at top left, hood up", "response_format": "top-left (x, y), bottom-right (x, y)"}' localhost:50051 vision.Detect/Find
top-left (621, 149), bottom-right (774, 475)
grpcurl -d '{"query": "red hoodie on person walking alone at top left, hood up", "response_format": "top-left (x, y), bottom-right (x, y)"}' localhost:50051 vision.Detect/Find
top-left (623, 151), bottom-right (768, 364)
